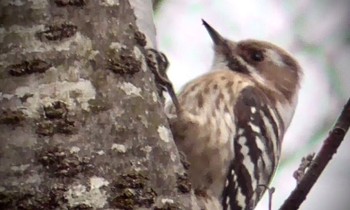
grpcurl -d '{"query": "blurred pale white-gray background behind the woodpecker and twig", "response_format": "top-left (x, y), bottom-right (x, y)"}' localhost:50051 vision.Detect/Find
top-left (155, 0), bottom-right (350, 210)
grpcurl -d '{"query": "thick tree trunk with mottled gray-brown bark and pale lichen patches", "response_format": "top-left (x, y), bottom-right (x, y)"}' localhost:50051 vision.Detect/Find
top-left (0, 0), bottom-right (197, 210)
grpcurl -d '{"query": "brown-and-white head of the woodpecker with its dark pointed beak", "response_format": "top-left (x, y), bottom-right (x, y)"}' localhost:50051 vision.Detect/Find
top-left (203, 20), bottom-right (302, 101)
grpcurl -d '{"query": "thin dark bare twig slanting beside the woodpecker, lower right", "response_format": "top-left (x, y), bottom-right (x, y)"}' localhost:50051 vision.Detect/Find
top-left (280, 98), bottom-right (350, 210)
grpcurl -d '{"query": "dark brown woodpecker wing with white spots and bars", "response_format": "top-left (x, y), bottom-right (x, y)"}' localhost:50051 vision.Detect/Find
top-left (222, 87), bottom-right (284, 210)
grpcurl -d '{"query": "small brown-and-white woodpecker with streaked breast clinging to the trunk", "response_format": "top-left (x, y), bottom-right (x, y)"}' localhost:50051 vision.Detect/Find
top-left (166, 20), bottom-right (302, 210)
